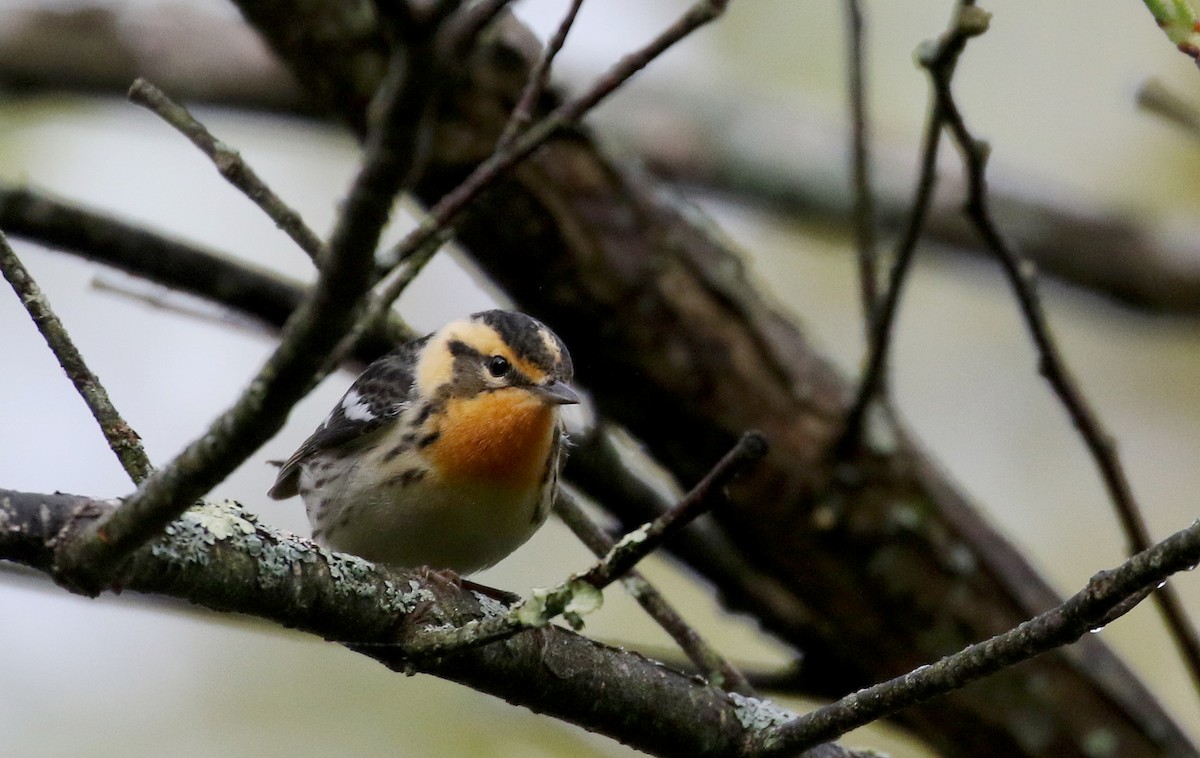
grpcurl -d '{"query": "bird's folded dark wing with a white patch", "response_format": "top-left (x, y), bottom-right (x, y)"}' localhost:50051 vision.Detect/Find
top-left (266, 337), bottom-right (428, 500)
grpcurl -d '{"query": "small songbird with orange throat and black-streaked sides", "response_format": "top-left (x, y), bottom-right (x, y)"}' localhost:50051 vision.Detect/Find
top-left (268, 311), bottom-right (580, 573)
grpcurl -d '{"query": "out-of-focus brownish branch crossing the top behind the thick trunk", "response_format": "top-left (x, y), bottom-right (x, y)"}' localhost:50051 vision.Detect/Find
top-left (0, 2), bottom-right (1200, 313)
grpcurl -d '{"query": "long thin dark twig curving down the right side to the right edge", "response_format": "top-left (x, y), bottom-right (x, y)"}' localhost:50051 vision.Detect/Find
top-left (922, 5), bottom-right (1200, 691)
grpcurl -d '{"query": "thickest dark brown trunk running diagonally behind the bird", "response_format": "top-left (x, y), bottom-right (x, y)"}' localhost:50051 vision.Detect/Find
top-left (4, 2), bottom-right (1192, 756)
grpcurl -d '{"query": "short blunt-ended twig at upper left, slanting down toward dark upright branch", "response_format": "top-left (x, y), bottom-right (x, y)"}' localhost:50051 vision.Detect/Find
top-left (128, 77), bottom-right (324, 260)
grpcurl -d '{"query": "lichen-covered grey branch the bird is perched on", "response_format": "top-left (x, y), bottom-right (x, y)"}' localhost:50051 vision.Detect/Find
top-left (0, 489), bottom-right (873, 758)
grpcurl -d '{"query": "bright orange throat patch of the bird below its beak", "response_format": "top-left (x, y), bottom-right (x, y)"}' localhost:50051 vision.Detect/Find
top-left (426, 387), bottom-right (554, 489)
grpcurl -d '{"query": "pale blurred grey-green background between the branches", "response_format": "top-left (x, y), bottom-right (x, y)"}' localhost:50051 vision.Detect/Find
top-left (0, 0), bottom-right (1200, 757)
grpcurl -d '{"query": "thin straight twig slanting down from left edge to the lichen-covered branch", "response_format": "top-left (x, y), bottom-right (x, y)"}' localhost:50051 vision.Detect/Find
top-left (0, 231), bottom-right (154, 483)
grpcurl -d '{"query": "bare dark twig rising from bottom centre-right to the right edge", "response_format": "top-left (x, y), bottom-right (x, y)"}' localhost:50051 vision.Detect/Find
top-left (756, 513), bottom-right (1200, 756)
